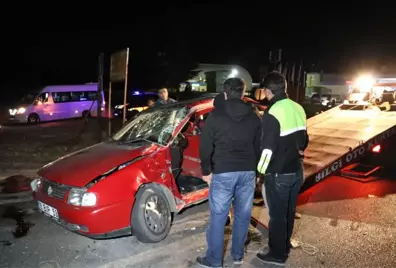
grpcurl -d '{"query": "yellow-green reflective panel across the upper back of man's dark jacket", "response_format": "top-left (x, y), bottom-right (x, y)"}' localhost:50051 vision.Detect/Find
top-left (268, 99), bottom-right (307, 137)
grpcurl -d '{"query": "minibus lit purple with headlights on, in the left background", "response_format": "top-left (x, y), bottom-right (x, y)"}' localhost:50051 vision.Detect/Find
top-left (9, 83), bottom-right (105, 124)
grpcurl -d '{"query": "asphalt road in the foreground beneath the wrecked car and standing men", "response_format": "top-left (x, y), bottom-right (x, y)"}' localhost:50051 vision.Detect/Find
top-left (0, 177), bottom-right (396, 268)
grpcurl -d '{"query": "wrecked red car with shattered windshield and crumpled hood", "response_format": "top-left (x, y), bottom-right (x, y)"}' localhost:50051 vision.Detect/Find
top-left (31, 94), bottom-right (264, 242)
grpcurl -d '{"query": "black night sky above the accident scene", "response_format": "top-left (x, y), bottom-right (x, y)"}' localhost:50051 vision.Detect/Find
top-left (0, 4), bottom-right (396, 91)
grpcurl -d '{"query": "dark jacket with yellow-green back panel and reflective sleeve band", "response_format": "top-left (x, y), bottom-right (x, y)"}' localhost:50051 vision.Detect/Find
top-left (261, 94), bottom-right (309, 174)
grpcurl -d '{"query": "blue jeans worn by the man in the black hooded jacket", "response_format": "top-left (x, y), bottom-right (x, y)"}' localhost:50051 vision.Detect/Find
top-left (206, 171), bottom-right (256, 266)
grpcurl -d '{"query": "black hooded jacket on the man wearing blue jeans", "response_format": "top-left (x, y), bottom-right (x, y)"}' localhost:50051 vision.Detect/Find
top-left (200, 94), bottom-right (261, 175)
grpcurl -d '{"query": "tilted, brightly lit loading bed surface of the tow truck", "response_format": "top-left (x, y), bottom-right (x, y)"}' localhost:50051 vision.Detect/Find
top-left (252, 105), bottom-right (396, 226)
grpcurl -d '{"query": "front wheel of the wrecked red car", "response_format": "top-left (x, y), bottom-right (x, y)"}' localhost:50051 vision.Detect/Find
top-left (131, 187), bottom-right (172, 243)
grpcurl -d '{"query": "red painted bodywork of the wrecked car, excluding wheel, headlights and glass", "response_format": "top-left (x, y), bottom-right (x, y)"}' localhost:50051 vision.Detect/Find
top-left (33, 95), bottom-right (266, 238)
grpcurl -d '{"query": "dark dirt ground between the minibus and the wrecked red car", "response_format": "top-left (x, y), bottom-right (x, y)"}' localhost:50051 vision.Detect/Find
top-left (0, 118), bottom-right (121, 172)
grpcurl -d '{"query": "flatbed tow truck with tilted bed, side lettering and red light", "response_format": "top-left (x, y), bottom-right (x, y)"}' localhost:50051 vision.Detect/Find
top-left (252, 74), bottom-right (396, 228)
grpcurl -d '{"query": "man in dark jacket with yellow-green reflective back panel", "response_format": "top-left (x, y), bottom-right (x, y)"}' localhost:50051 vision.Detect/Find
top-left (257, 72), bottom-right (309, 265)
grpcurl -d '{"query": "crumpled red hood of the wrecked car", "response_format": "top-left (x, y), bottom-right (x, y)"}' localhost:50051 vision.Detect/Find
top-left (38, 142), bottom-right (156, 187)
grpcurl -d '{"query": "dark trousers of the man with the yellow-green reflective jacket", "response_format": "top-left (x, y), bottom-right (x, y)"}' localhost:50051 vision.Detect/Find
top-left (264, 164), bottom-right (304, 259)
